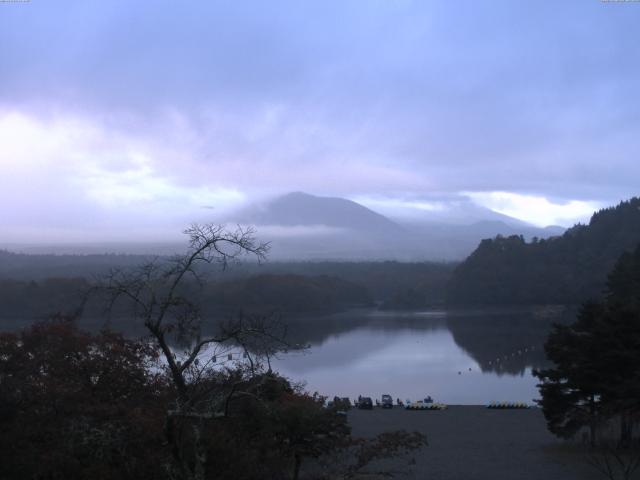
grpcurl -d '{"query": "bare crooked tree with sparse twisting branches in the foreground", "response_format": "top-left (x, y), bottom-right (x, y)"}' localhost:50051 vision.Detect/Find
top-left (100, 224), bottom-right (285, 480)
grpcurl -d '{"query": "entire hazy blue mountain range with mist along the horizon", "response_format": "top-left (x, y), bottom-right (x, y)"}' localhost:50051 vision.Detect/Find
top-left (0, 192), bottom-right (564, 260)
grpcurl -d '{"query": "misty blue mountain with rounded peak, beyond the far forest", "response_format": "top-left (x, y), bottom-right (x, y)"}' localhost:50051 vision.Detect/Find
top-left (224, 192), bottom-right (562, 261)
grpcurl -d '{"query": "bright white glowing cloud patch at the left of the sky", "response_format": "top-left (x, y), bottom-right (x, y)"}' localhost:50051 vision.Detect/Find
top-left (0, 111), bottom-right (246, 240)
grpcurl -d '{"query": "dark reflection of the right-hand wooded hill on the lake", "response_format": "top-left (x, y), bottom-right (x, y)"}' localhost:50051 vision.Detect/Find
top-left (447, 307), bottom-right (575, 375)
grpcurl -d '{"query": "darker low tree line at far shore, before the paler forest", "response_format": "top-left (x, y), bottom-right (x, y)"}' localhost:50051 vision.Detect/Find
top-left (0, 274), bottom-right (373, 325)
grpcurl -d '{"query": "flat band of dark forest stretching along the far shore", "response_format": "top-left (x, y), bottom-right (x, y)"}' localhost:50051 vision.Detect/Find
top-left (0, 251), bottom-right (454, 328)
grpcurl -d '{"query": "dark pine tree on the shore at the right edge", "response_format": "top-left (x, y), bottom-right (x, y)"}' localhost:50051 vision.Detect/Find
top-left (534, 246), bottom-right (640, 446)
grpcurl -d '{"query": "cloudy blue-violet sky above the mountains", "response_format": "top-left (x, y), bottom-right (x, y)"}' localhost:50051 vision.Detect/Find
top-left (0, 0), bottom-right (640, 242)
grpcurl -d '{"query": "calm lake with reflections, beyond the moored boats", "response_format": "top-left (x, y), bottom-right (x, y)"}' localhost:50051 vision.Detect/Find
top-left (273, 307), bottom-right (572, 405)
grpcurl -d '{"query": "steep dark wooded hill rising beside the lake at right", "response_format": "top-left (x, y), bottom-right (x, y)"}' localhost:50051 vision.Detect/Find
top-left (447, 197), bottom-right (640, 305)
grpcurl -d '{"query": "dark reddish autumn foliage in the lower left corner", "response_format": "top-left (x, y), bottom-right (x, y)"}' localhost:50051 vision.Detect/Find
top-left (0, 318), bottom-right (166, 479)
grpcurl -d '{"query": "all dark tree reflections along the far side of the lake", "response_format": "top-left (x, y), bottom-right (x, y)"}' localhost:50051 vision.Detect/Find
top-left (47, 307), bottom-right (575, 375)
